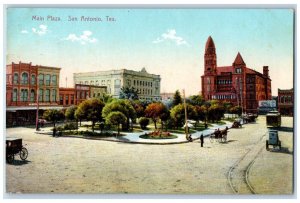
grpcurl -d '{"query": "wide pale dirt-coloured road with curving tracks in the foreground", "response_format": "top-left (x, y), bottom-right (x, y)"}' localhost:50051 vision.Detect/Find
top-left (6, 117), bottom-right (293, 194)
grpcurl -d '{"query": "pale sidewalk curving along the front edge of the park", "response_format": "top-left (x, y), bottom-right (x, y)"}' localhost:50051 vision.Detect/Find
top-left (36, 121), bottom-right (232, 144)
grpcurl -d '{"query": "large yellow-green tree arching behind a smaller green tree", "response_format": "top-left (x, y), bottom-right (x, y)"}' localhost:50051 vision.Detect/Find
top-left (102, 99), bottom-right (136, 130)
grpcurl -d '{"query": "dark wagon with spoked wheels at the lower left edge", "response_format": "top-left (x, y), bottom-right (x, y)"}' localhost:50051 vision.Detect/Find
top-left (6, 138), bottom-right (28, 163)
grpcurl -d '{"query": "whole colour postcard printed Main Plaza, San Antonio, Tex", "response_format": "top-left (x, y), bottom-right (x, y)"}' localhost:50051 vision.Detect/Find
top-left (5, 6), bottom-right (295, 197)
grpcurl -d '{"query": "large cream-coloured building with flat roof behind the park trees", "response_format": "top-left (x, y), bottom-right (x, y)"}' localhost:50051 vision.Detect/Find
top-left (73, 68), bottom-right (161, 101)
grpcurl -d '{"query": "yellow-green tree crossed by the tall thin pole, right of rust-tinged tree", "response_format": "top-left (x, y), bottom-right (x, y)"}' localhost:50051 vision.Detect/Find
top-left (171, 104), bottom-right (197, 127)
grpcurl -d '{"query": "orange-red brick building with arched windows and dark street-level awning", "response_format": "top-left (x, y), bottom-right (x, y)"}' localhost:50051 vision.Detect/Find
top-left (6, 62), bottom-right (60, 126)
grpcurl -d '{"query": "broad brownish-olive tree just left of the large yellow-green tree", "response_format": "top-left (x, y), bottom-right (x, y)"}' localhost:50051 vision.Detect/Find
top-left (78, 98), bottom-right (104, 132)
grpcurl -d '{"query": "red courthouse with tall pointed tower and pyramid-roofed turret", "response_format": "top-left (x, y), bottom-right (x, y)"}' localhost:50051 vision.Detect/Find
top-left (201, 37), bottom-right (272, 113)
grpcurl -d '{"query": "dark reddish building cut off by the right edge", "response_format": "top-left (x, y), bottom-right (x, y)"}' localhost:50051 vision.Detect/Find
top-left (278, 88), bottom-right (294, 116)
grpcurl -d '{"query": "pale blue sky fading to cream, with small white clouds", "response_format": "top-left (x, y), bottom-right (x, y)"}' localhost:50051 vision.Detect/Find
top-left (6, 8), bottom-right (294, 96)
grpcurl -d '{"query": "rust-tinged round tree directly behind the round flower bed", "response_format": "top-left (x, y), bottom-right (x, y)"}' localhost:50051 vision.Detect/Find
top-left (145, 103), bottom-right (168, 129)
